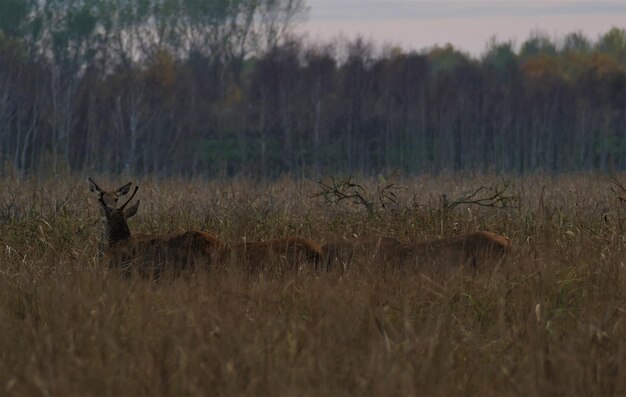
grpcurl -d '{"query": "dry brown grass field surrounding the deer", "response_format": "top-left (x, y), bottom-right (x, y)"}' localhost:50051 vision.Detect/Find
top-left (0, 174), bottom-right (626, 396)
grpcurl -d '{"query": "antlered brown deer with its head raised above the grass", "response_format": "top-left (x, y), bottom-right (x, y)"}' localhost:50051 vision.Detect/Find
top-left (98, 186), bottom-right (224, 279)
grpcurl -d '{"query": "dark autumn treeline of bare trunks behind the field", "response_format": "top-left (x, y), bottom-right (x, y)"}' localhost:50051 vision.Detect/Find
top-left (0, 0), bottom-right (626, 176)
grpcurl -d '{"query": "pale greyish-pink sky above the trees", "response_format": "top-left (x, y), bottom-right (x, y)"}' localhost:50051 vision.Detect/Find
top-left (298, 0), bottom-right (626, 56)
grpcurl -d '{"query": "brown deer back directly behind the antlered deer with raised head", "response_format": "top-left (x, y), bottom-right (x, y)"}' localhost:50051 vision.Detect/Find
top-left (230, 237), bottom-right (322, 270)
